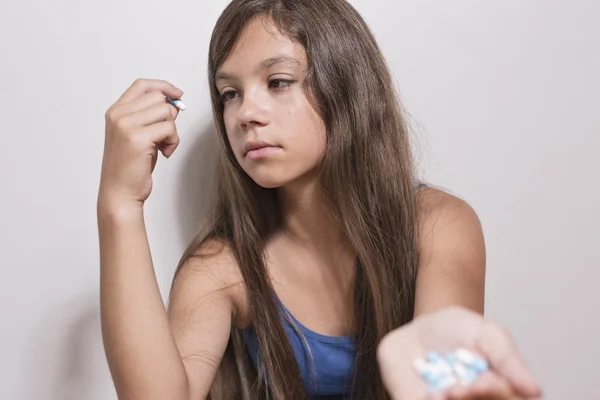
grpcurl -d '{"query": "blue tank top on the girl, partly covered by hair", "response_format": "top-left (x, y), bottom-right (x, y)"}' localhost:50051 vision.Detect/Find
top-left (242, 296), bottom-right (356, 399)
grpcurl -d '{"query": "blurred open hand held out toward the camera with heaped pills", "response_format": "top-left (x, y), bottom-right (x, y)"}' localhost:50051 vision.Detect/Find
top-left (378, 307), bottom-right (541, 400)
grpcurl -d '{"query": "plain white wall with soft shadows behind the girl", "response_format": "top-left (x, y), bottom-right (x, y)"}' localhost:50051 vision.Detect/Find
top-left (0, 0), bottom-right (600, 400)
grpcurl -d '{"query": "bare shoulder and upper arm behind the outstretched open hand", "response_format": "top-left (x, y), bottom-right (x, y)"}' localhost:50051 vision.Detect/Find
top-left (415, 187), bottom-right (486, 315)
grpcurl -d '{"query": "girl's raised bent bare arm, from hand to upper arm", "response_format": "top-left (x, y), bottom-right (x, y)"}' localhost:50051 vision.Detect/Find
top-left (97, 79), bottom-right (238, 400)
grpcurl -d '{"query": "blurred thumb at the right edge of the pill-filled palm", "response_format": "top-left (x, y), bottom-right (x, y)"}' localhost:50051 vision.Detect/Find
top-left (477, 321), bottom-right (541, 397)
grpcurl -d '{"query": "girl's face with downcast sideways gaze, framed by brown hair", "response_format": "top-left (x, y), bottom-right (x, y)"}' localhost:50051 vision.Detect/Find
top-left (216, 18), bottom-right (325, 188)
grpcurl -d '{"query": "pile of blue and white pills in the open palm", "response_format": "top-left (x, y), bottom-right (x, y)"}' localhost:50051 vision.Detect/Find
top-left (414, 349), bottom-right (489, 391)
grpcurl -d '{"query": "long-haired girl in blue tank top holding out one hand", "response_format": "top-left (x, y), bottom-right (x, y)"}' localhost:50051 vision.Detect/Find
top-left (98, 0), bottom-right (539, 400)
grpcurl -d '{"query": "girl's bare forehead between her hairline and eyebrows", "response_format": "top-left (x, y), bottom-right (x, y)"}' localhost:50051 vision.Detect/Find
top-left (219, 18), bottom-right (306, 75)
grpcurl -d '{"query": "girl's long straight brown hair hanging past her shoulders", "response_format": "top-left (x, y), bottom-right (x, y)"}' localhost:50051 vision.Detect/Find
top-left (170, 0), bottom-right (418, 400)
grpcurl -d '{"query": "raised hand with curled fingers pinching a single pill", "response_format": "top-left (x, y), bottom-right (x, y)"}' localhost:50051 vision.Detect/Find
top-left (98, 79), bottom-right (185, 205)
